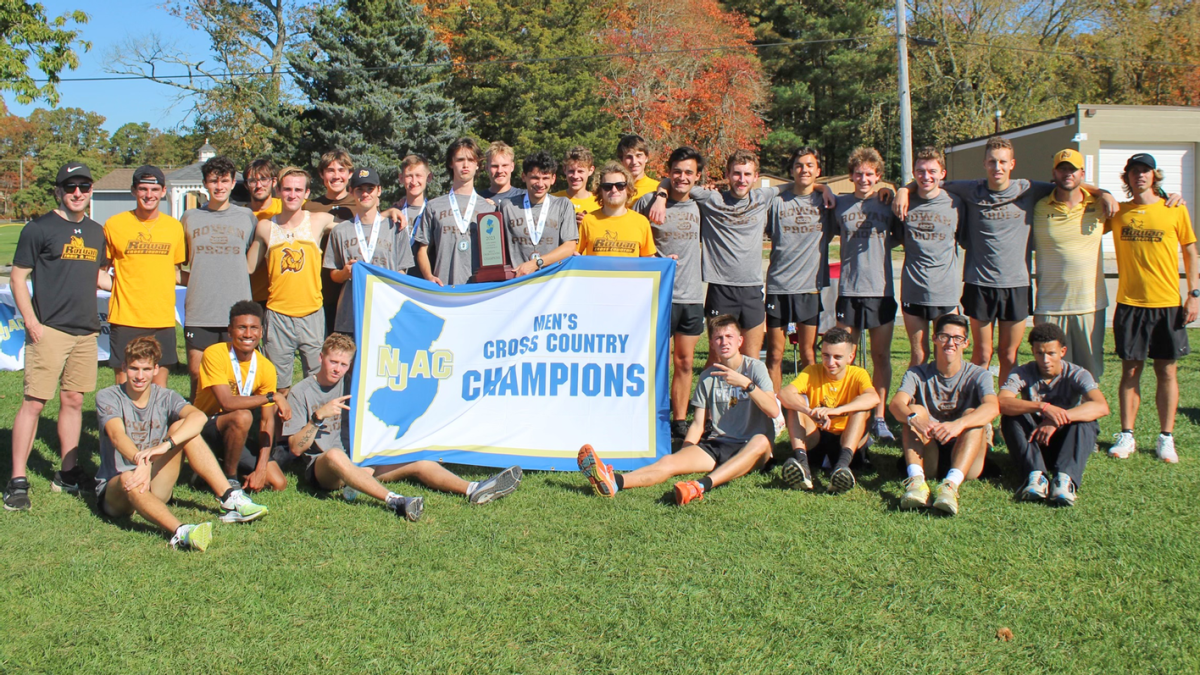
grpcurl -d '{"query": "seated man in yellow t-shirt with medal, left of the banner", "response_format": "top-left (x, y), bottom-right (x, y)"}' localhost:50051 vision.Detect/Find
top-left (196, 300), bottom-right (292, 490)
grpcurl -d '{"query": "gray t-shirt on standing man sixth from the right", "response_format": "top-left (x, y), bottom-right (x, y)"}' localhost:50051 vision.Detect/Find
top-left (767, 190), bottom-right (833, 295)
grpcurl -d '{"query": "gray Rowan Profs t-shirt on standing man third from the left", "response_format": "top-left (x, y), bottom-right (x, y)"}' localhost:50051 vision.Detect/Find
top-left (180, 205), bottom-right (256, 328)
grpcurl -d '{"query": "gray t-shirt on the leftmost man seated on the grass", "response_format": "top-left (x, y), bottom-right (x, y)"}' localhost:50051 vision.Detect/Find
top-left (96, 381), bottom-right (187, 480)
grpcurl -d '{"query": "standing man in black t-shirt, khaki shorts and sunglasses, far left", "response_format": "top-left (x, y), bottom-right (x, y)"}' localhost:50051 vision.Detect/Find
top-left (4, 162), bottom-right (113, 510)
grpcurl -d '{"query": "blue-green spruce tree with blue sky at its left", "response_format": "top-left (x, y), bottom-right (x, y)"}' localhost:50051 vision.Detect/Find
top-left (278, 0), bottom-right (467, 191)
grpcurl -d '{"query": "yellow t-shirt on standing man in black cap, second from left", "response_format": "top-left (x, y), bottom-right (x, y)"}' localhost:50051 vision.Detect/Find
top-left (104, 211), bottom-right (187, 328)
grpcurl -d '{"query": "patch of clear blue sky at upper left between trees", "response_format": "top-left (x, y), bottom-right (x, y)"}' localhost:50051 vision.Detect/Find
top-left (4, 0), bottom-right (209, 132)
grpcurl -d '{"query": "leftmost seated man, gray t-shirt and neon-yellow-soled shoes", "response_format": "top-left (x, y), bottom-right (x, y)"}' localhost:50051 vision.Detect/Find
top-left (96, 336), bottom-right (266, 551)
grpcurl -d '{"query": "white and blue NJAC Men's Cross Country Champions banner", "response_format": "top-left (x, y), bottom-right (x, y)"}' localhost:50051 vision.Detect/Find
top-left (350, 256), bottom-right (674, 471)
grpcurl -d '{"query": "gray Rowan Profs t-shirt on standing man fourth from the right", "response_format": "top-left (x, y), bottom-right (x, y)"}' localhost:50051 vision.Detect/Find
top-left (892, 190), bottom-right (966, 307)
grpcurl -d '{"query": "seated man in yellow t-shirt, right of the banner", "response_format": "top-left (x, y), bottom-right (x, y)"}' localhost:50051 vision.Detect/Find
top-left (779, 328), bottom-right (880, 492)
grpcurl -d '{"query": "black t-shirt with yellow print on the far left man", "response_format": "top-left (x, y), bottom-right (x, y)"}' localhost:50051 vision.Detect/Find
top-left (12, 211), bottom-right (108, 335)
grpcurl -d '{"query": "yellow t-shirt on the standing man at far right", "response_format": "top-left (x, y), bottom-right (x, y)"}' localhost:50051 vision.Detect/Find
top-left (1105, 201), bottom-right (1196, 307)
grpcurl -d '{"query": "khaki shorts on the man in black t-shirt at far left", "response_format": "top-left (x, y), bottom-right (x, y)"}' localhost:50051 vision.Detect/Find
top-left (25, 325), bottom-right (97, 401)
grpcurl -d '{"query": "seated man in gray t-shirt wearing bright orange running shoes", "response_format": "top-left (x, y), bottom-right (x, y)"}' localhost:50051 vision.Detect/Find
top-left (578, 315), bottom-right (779, 506)
